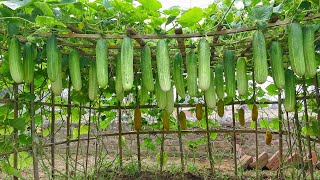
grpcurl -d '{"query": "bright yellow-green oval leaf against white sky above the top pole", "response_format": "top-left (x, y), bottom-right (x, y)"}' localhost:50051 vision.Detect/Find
top-left (178, 7), bottom-right (204, 27)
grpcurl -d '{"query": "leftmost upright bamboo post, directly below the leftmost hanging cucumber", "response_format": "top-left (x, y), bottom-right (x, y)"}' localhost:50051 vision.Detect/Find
top-left (13, 83), bottom-right (19, 180)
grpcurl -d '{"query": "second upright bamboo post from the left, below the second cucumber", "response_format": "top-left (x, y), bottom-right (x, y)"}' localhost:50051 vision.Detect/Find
top-left (30, 81), bottom-right (39, 180)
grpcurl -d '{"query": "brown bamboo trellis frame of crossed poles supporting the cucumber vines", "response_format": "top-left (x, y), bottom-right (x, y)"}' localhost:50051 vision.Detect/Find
top-left (0, 14), bottom-right (320, 179)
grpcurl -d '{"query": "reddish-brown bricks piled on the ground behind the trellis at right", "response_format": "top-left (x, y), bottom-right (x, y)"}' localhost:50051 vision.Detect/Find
top-left (238, 151), bottom-right (320, 171)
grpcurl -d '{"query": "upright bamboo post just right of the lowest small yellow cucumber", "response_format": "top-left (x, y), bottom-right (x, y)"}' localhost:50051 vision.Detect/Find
top-left (278, 93), bottom-right (283, 179)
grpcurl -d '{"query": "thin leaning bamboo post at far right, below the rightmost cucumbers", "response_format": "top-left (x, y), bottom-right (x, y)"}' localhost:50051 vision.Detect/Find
top-left (302, 77), bottom-right (314, 180)
